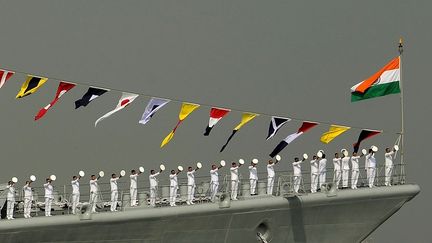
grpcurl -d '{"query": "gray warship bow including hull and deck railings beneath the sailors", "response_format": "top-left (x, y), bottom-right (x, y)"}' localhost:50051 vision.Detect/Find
top-left (0, 160), bottom-right (420, 242)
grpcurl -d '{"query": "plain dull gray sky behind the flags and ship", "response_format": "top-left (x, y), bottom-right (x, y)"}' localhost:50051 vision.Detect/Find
top-left (0, 0), bottom-right (432, 242)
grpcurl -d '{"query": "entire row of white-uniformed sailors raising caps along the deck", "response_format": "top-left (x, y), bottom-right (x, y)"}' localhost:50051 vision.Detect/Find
top-left (1, 146), bottom-right (398, 219)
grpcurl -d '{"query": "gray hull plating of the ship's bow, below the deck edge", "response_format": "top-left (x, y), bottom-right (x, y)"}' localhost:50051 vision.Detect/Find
top-left (0, 185), bottom-right (420, 243)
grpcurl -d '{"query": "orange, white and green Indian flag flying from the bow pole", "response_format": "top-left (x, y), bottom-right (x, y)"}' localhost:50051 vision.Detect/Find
top-left (351, 57), bottom-right (401, 102)
